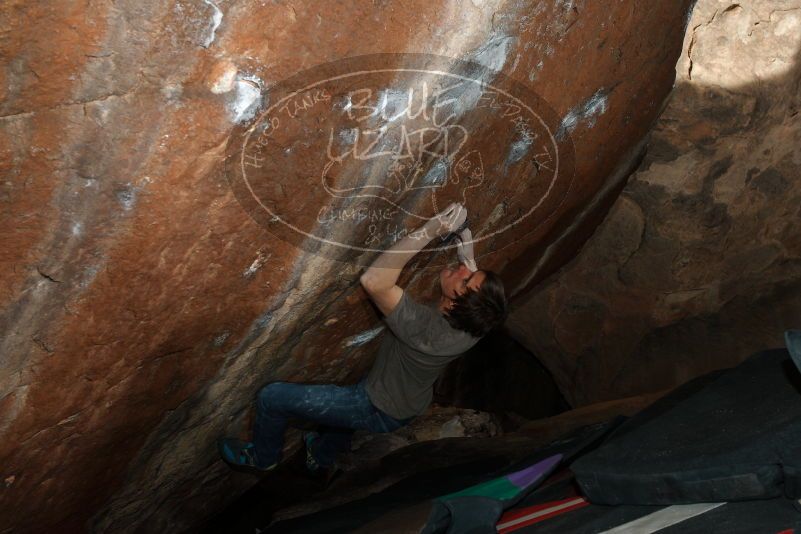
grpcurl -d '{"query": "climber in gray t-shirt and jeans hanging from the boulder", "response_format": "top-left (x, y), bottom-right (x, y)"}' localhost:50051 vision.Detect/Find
top-left (218, 203), bottom-right (507, 477)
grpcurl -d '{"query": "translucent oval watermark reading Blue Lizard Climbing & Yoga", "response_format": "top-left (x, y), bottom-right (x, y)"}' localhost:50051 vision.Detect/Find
top-left (226, 54), bottom-right (574, 266)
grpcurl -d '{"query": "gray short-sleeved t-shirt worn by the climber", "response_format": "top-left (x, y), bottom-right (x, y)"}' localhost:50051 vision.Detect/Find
top-left (365, 291), bottom-right (479, 426)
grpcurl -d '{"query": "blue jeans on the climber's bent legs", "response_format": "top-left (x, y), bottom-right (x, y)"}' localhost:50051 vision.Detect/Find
top-left (253, 380), bottom-right (414, 467)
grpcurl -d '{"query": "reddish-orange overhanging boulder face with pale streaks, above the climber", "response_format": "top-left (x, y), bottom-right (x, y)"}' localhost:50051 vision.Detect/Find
top-left (0, 0), bottom-right (691, 532)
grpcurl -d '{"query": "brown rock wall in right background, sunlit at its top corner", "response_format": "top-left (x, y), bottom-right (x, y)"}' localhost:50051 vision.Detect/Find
top-left (509, 0), bottom-right (801, 405)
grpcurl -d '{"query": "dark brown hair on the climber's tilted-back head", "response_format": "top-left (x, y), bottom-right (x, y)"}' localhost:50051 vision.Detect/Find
top-left (445, 271), bottom-right (509, 337)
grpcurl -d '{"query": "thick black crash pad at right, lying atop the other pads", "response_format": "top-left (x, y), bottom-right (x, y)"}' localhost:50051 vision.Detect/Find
top-left (572, 342), bottom-right (801, 505)
